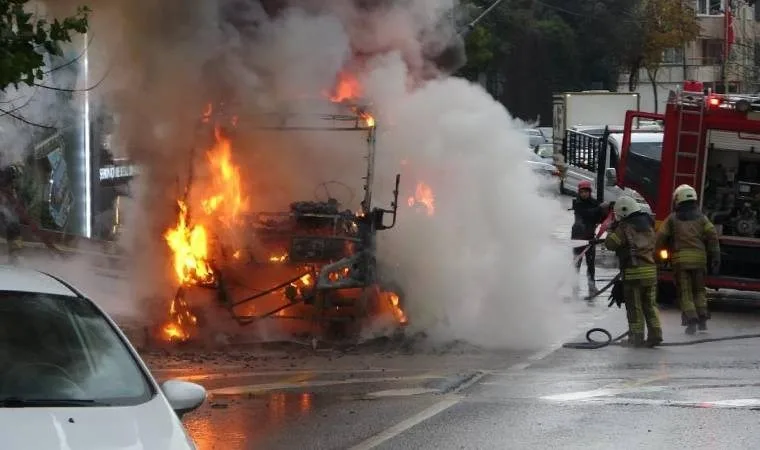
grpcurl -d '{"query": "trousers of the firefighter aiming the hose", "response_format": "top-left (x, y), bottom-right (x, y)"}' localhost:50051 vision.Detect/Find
top-left (623, 280), bottom-right (662, 340)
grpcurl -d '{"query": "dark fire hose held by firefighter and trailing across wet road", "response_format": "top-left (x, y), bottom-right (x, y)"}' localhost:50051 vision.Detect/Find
top-left (562, 215), bottom-right (760, 350)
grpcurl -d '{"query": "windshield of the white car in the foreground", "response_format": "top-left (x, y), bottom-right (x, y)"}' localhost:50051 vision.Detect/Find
top-left (0, 291), bottom-right (155, 407)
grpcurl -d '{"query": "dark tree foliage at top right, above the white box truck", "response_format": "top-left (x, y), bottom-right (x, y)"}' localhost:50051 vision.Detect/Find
top-left (459, 0), bottom-right (699, 119)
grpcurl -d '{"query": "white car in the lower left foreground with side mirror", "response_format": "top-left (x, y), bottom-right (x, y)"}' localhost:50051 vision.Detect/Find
top-left (0, 266), bottom-right (206, 450)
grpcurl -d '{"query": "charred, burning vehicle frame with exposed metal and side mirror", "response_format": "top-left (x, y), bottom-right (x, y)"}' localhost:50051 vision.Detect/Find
top-left (184, 106), bottom-right (405, 338)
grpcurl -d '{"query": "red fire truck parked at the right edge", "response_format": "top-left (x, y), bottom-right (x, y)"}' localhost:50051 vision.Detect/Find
top-left (614, 82), bottom-right (760, 299)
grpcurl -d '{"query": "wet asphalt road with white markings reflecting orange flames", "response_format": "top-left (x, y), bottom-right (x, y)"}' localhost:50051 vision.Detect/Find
top-left (134, 195), bottom-right (760, 450)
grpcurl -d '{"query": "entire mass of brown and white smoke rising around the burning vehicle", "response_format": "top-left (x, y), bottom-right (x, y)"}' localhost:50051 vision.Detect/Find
top-left (5, 0), bottom-right (580, 347)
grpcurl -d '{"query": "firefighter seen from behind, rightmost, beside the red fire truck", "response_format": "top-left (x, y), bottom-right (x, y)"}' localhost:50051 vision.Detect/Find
top-left (657, 184), bottom-right (720, 334)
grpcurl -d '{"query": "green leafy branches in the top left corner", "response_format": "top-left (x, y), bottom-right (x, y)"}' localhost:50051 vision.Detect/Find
top-left (0, 0), bottom-right (91, 90)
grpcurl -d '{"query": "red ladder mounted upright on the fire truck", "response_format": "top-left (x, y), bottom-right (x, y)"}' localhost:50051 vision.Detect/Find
top-left (673, 93), bottom-right (706, 188)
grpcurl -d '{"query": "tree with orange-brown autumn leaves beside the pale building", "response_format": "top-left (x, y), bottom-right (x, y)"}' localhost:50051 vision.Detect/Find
top-left (630, 0), bottom-right (700, 113)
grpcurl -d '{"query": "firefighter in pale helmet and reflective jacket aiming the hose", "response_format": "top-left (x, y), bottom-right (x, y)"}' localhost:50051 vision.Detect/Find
top-left (604, 195), bottom-right (662, 347)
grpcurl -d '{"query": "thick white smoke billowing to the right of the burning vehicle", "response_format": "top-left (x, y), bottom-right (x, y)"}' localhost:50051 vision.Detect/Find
top-left (239, 1), bottom-right (571, 348)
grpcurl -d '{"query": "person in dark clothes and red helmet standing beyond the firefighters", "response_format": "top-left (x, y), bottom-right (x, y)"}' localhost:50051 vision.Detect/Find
top-left (570, 180), bottom-right (606, 297)
